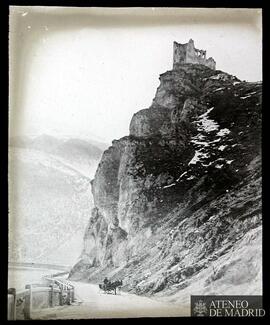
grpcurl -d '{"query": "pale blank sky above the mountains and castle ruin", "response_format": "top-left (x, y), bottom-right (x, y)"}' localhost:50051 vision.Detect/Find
top-left (9, 6), bottom-right (262, 143)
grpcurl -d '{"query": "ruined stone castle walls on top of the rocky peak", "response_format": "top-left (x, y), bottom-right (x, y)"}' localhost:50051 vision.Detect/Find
top-left (173, 39), bottom-right (216, 70)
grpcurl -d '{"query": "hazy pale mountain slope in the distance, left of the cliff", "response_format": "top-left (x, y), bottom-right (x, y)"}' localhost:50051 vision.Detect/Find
top-left (9, 135), bottom-right (105, 265)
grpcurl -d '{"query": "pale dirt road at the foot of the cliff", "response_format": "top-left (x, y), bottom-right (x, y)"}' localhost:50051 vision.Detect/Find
top-left (32, 282), bottom-right (189, 319)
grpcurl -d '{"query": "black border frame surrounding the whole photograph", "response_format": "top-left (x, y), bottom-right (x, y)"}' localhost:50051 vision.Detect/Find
top-left (0, 0), bottom-right (270, 323)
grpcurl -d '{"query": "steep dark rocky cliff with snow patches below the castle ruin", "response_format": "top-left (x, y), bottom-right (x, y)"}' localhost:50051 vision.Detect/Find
top-left (70, 64), bottom-right (261, 302)
